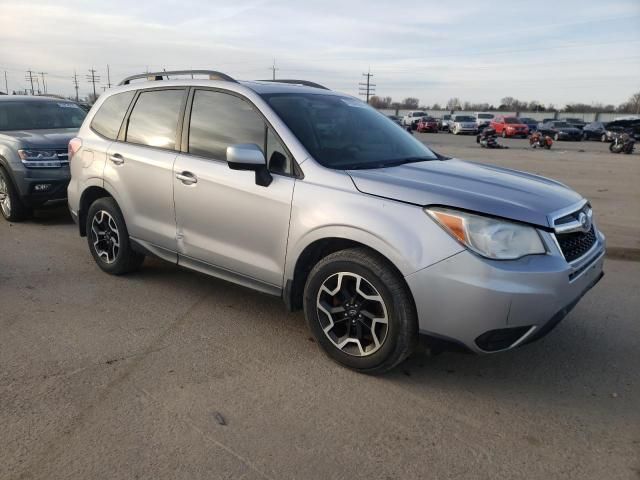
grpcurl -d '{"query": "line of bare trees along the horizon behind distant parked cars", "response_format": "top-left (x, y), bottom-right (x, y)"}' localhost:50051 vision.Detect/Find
top-left (369, 92), bottom-right (640, 114)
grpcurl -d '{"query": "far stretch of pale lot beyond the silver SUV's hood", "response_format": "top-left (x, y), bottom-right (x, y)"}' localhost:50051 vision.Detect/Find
top-left (416, 133), bottom-right (640, 260)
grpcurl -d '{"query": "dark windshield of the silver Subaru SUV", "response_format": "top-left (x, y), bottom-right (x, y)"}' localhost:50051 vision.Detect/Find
top-left (262, 93), bottom-right (438, 170)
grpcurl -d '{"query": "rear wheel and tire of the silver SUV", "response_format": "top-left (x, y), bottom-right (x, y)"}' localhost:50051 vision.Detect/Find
top-left (87, 197), bottom-right (144, 275)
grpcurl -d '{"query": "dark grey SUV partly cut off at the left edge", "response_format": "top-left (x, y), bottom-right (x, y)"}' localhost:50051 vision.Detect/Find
top-left (0, 95), bottom-right (87, 222)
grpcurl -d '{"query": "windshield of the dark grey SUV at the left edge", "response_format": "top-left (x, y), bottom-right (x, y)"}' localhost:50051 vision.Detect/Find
top-left (0, 100), bottom-right (87, 130)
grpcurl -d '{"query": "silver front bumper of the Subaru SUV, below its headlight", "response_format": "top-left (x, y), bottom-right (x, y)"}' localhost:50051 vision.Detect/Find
top-left (405, 229), bottom-right (605, 353)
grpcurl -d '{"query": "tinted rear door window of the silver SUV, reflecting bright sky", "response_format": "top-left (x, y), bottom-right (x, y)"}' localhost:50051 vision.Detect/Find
top-left (127, 90), bottom-right (185, 149)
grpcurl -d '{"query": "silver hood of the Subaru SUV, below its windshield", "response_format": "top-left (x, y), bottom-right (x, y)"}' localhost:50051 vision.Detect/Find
top-left (348, 159), bottom-right (582, 227)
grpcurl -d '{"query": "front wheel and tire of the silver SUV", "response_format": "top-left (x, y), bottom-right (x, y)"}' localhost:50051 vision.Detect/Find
top-left (304, 248), bottom-right (418, 374)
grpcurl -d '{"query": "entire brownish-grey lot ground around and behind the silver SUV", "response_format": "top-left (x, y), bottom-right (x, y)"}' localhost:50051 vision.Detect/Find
top-left (0, 138), bottom-right (640, 480)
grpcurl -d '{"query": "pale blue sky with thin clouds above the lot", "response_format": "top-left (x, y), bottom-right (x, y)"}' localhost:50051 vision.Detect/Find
top-left (0, 0), bottom-right (640, 106)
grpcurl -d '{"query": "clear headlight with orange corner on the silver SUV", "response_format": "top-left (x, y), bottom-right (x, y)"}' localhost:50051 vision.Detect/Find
top-left (425, 207), bottom-right (546, 260)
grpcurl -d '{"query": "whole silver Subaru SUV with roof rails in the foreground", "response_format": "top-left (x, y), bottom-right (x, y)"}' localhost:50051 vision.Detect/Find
top-left (68, 71), bottom-right (605, 373)
